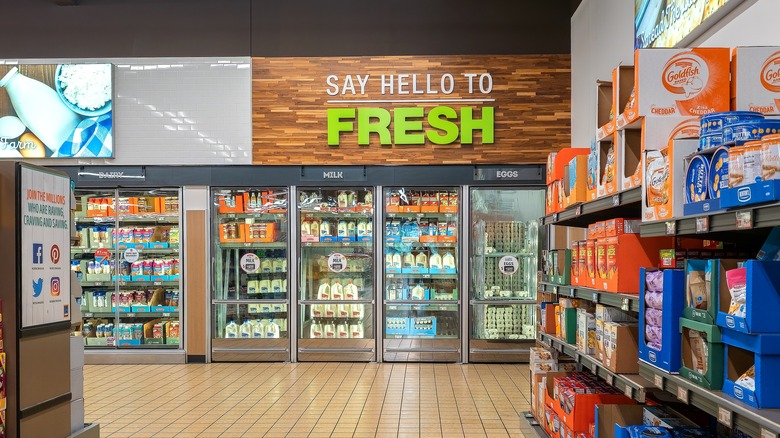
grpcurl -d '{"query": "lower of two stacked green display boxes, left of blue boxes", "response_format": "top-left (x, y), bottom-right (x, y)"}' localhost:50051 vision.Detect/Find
top-left (680, 318), bottom-right (723, 389)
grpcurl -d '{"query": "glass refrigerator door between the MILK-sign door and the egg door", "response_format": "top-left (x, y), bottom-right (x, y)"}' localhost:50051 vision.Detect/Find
top-left (383, 187), bottom-right (461, 362)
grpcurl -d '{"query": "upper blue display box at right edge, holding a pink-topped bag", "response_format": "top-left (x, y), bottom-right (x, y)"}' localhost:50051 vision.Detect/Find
top-left (716, 260), bottom-right (780, 333)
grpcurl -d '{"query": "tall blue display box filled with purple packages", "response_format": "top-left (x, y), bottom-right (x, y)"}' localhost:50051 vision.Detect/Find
top-left (639, 268), bottom-right (685, 374)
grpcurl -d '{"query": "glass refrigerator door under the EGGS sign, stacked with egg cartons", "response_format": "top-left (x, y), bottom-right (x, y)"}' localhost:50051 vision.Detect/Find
top-left (469, 188), bottom-right (544, 362)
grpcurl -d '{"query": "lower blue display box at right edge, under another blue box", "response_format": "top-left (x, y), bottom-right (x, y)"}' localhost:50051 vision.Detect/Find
top-left (722, 329), bottom-right (780, 409)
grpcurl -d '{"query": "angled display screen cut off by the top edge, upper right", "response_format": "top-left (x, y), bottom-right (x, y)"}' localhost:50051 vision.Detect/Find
top-left (634, 0), bottom-right (741, 49)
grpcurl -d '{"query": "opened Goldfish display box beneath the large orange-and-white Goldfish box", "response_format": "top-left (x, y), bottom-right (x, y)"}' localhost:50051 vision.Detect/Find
top-left (642, 117), bottom-right (699, 222)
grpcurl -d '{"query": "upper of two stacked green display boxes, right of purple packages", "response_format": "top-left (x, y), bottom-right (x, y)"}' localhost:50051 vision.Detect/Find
top-left (683, 259), bottom-right (740, 324)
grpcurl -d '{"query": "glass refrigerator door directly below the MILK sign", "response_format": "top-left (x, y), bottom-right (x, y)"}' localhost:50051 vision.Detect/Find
top-left (297, 187), bottom-right (376, 361)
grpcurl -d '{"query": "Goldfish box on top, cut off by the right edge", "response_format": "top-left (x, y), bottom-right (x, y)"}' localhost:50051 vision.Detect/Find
top-left (731, 47), bottom-right (780, 115)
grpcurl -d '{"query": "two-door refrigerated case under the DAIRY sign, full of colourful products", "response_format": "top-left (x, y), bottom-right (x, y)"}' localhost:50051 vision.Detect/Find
top-left (71, 189), bottom-right (184, 351)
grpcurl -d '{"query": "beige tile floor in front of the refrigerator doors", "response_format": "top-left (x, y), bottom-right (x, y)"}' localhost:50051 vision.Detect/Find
top-left (84, 363), bottom-right (536, 438)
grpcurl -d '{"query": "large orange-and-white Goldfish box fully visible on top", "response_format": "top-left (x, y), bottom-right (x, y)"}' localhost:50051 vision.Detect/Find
top-left (634, 48), bottom-right (731, 117)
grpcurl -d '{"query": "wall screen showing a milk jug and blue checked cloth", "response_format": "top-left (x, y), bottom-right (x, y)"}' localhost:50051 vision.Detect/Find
top-left (0, 64), bottom-right (114, 159)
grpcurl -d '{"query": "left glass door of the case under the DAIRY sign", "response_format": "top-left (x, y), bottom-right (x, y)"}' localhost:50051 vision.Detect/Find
top-left (70, 190), bottom-right (117, 349)
